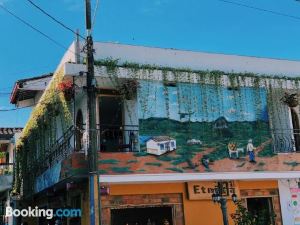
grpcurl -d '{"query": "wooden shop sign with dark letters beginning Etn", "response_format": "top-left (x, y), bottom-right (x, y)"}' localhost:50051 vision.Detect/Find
top-left (187, 181), bottom-right (239, 200)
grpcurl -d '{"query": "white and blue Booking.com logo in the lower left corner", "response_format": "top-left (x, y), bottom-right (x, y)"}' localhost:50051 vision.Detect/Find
top-left (5, 206), bottom-right (81, 219)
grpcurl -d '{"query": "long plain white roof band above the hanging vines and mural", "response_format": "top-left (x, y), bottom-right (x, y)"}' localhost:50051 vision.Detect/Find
top-left (88, 42), bottom-right (300, 77)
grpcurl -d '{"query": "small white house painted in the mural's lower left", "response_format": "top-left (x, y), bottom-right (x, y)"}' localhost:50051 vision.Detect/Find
top-left (146, 136), bottom-right (176, 155)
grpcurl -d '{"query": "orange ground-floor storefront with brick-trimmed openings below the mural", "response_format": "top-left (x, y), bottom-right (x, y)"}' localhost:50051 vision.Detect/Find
top-left (101, 180), bottom-right (282, 225)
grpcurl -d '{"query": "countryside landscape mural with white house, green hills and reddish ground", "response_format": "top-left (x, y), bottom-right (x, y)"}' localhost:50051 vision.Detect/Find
top-left (99, 81), bottom-right (300, 174)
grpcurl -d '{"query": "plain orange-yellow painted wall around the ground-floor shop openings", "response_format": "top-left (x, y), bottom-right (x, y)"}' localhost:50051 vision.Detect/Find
top-left (110, 181), bottom-right (277, 225)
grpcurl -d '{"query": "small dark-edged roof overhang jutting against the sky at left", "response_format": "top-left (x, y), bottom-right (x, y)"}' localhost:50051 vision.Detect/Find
top-left (10, 73), bottom-right (53, 104)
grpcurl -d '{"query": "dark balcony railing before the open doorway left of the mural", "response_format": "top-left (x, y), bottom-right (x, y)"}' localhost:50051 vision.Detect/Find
top-left (97, 124), bottom-right (139, 152)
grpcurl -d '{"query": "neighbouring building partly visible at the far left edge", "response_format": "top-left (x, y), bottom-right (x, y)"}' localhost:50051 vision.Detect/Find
top-left (0, 127), bottom-right (22, 225)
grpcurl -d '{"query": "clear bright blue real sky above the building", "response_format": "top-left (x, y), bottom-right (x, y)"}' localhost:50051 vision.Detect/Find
top-left (0, 0), bottom-right (300, 127)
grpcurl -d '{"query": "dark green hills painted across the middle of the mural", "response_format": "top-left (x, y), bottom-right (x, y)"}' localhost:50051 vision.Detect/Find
top-left (139, 117), bottom-right (273, 161)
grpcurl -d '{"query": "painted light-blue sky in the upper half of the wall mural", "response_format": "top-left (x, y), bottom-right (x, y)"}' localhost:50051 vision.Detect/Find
top-left (139, 81), bottom-right (268, 122)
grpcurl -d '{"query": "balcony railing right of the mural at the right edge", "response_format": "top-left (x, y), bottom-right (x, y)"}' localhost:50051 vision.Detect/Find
top-left (271, 129), bottom-right (300, 153)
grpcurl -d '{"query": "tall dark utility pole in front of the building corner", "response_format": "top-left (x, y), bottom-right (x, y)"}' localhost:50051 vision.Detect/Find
top-left (85, 0), bottom-right (101, 225)
